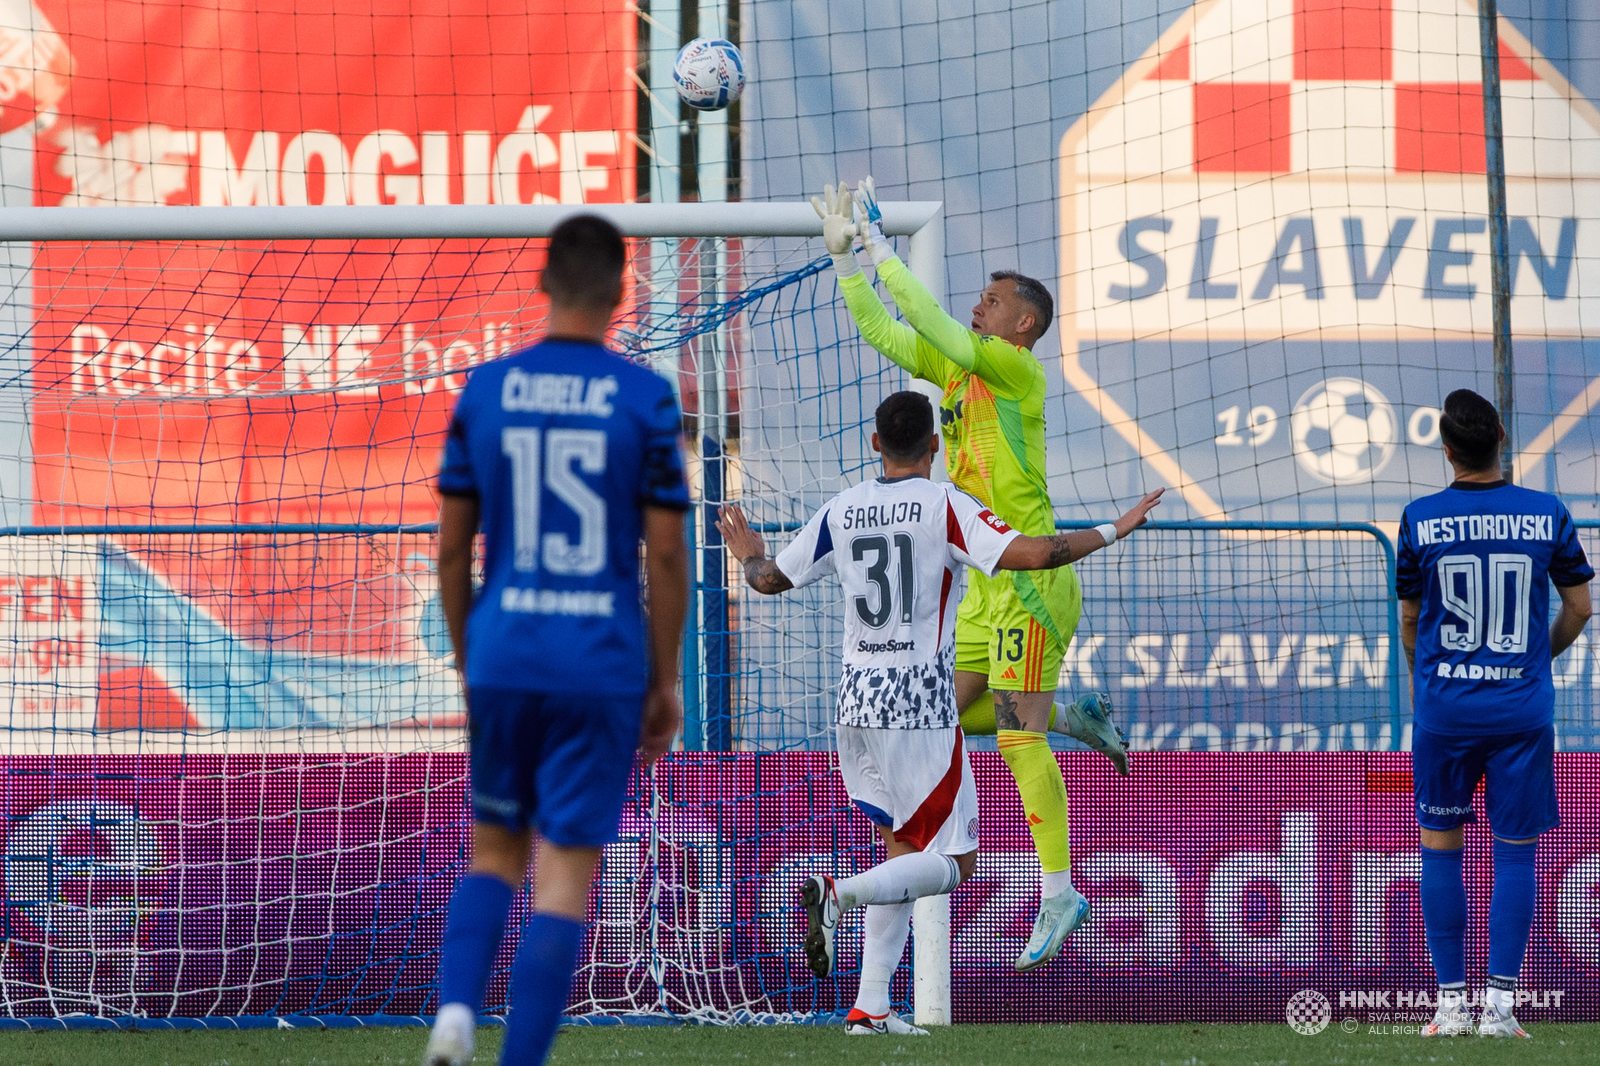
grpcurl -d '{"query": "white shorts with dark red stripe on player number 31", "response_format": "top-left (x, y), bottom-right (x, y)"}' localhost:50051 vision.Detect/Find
top-left (835, 725), bottom-right (978, 855)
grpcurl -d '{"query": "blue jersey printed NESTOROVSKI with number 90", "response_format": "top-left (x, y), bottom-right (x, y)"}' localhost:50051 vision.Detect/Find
top-left (1395, 482), bottom-right (1595, 736)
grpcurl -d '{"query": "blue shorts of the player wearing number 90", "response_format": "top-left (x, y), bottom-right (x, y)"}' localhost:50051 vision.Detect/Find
top-left (1411, 725), bottom-right (1562, 840)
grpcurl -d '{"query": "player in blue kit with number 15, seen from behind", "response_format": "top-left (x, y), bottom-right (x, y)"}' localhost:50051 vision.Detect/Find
top-left (424, 214), bottom-right (688, 1066)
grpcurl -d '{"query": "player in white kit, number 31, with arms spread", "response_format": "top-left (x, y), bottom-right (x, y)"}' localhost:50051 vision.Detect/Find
top-left (717, 392), bottom-right (1162, 1036)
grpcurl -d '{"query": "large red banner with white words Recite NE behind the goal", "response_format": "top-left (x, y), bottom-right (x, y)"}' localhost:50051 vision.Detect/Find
top-left (23, 0), bottom-right (635, 522)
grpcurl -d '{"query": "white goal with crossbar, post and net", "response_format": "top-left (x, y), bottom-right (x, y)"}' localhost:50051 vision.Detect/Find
top-left (0, 202), bottom-right (950, 1024)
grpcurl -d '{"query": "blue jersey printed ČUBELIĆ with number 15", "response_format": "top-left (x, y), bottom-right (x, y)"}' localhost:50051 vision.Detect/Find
top-left (438, 339), bottom-right (690, 695)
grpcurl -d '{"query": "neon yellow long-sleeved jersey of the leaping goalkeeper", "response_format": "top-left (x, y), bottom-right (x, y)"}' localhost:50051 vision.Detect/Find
top-left (838, 258), bottom-right (1056, 536)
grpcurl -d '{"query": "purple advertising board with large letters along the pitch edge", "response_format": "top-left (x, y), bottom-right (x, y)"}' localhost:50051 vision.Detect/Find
top-left (0, 752), bottom-right (1600, 1023)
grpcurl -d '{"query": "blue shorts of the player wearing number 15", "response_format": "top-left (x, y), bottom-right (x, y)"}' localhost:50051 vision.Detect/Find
top-left (467, 687), bottom-right (643, 848)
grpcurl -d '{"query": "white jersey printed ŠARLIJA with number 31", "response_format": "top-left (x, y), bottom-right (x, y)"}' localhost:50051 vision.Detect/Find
top-left (776, 477), bottom-right (1021, 730)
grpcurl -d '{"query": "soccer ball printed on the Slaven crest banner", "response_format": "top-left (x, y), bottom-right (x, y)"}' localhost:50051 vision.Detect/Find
top-left (1290, 378), bottom-right (1400, 485)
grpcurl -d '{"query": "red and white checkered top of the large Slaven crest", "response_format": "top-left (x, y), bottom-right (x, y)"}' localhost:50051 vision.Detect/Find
top-left (1088, 0), bottom-right (1600, 178)
